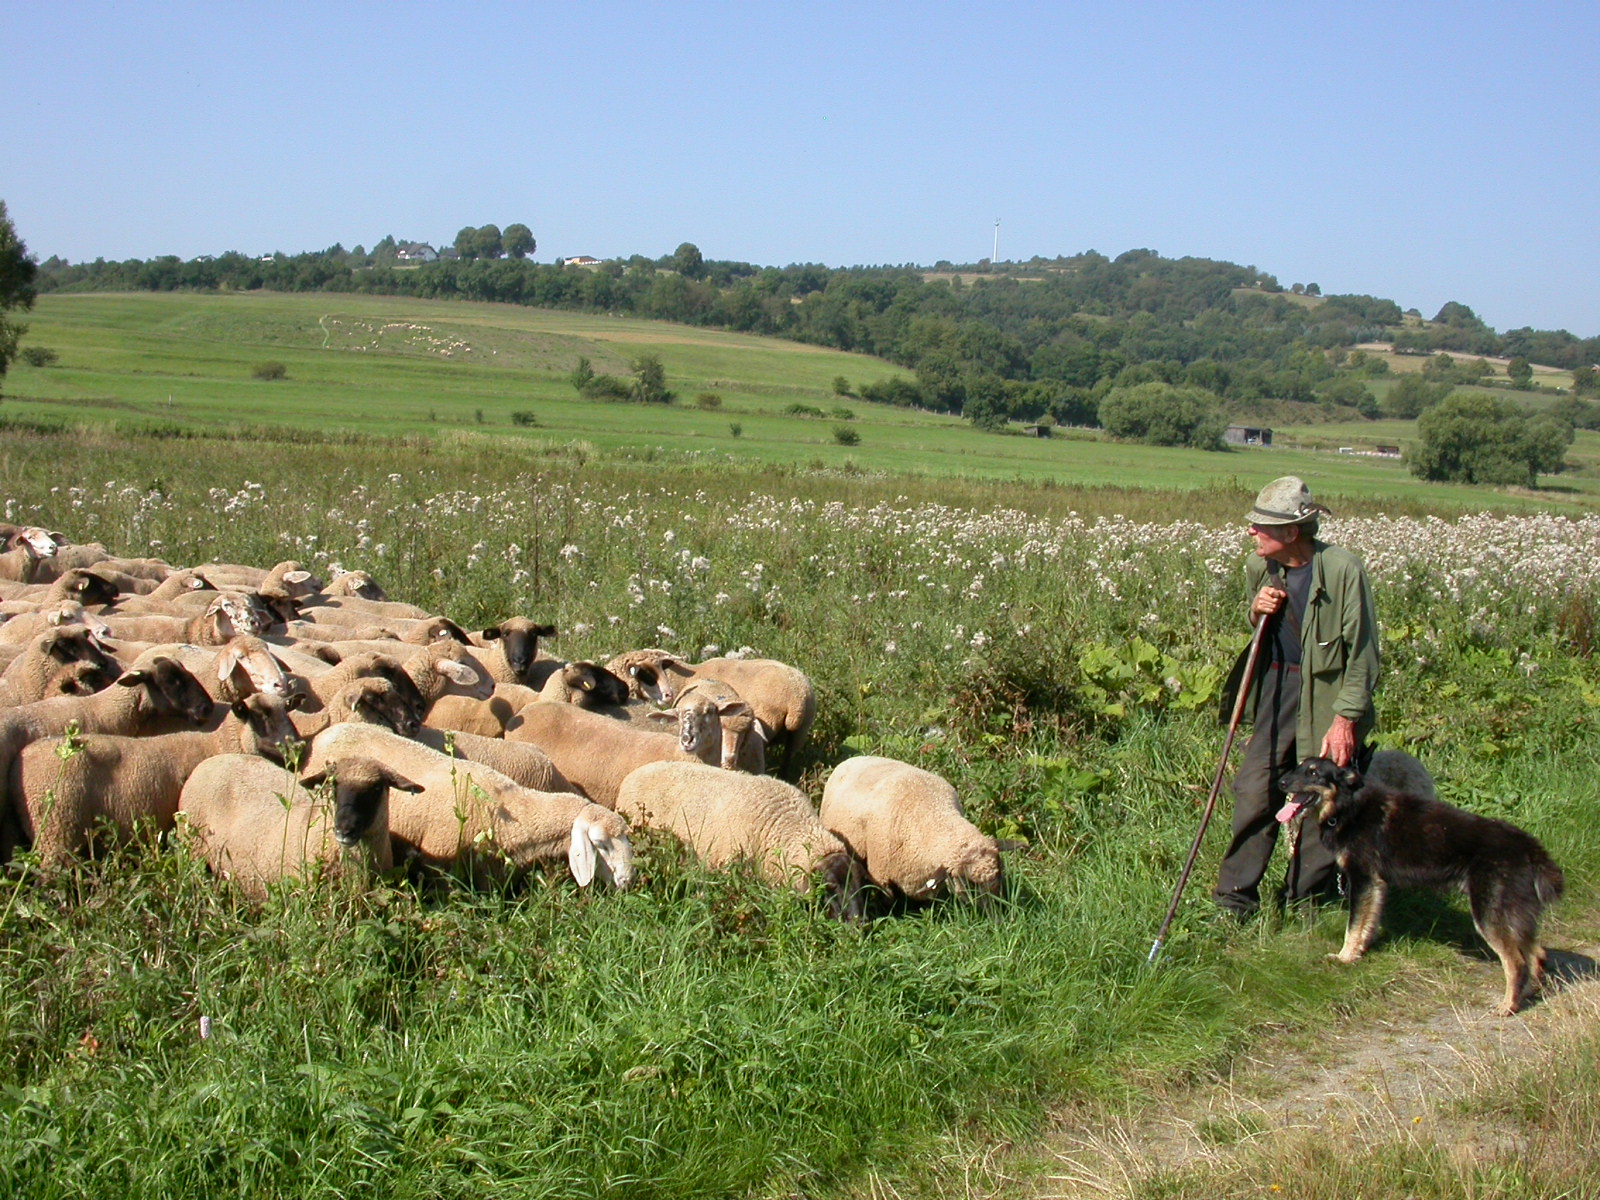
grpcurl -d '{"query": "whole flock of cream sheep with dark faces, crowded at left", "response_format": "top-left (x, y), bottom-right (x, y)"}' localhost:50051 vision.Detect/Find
top-left (0, 525), bottom-right (1002, 917)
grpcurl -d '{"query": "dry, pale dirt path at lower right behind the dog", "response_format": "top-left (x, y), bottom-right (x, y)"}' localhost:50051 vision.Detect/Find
top-left (1027, 946), bottom-right (1600, 1200)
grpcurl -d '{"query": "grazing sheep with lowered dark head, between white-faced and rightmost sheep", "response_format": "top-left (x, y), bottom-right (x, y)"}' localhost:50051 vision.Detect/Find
top-left (616, 762), bottom-right (861, 920)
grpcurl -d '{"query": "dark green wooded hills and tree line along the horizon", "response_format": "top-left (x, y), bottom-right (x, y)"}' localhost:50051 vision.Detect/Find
top-left (21, 226), bottom-right (1600, 443)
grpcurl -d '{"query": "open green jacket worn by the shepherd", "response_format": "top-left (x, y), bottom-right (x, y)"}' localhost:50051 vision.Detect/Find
top-left (1245, 539), bottom-right (1378, 757)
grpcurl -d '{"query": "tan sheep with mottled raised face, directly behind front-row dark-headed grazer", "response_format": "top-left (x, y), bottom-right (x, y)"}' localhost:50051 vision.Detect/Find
top-left (507, 699), bottom-right (722, 808)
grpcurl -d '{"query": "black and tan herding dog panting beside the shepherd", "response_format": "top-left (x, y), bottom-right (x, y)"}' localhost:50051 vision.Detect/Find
top-left (1278, 758), bottom-right (1565, 1016)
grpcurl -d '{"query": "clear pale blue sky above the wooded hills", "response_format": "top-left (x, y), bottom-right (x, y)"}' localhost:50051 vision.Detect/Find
top-left (0, 0), bottom-right (1600, 336)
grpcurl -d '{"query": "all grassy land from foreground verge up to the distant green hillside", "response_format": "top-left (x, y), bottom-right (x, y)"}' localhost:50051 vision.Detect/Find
top-left (0, 296), bottom-right (1600, 1200)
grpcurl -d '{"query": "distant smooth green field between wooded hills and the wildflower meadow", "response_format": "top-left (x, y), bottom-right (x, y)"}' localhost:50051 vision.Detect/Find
top-left (9, 293), bottom-right (1600, 512)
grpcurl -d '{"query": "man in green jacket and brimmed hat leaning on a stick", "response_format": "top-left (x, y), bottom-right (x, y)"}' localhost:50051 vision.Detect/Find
top-left (1213, 475), bottom-right (1378, 915)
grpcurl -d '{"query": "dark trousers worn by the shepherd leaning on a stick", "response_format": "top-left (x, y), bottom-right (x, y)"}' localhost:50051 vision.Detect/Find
top-left (1211, 664), bottom-right (1339, 912)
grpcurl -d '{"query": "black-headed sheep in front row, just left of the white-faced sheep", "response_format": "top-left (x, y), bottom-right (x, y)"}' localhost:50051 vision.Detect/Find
top-left (178, 754), bottom-right (422, 901)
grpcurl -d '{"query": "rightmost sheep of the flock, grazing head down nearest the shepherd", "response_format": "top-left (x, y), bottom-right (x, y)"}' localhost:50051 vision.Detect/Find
top-left (822, 755), bottom-right (1005, 901)
